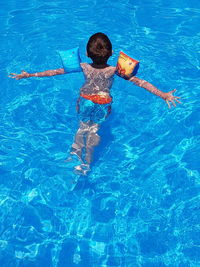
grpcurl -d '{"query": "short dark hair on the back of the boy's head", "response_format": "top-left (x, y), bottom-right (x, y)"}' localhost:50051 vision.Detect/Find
top-left (87, 32), bottom-right (112, 65)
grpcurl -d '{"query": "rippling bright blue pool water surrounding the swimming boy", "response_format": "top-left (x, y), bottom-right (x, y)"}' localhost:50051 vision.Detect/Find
top-left (0, 0), bottom-right (200, 267)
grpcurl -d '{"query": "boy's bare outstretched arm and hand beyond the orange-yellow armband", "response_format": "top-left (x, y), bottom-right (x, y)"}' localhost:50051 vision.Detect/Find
top-left (129, 76), bottom-right (181, 108)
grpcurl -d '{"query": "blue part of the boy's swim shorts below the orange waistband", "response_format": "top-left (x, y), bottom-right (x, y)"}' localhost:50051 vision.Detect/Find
top-left (76, 97), bottom-right (111, 123)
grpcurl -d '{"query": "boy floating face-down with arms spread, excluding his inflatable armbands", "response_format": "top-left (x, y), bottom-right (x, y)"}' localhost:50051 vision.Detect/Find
top-left (11, 33), bottom-right (180, 174)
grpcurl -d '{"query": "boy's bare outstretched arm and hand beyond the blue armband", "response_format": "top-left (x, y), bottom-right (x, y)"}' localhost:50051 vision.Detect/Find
top-left (9, 68), bottom-right (65, 80)
